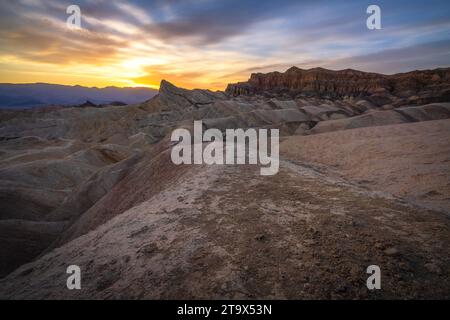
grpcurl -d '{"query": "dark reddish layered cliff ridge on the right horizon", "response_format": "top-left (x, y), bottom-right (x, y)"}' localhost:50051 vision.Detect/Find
top-left (226, 67), bottom-right (450, 102)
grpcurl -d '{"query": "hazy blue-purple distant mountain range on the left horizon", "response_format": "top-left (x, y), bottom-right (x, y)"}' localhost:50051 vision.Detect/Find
top-left (0, 83), bottom-right (158, 109)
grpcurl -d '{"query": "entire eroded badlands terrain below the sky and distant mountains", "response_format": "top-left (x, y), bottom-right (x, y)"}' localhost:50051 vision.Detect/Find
top-left (0, 69), bottom-right (450, 299)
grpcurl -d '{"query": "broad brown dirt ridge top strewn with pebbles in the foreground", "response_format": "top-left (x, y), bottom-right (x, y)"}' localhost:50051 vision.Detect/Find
top-left (0, 161), bottom-right (450, 299)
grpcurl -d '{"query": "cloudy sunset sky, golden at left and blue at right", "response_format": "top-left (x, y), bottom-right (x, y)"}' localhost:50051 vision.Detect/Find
top-left (0, 0), bottom-right (450, 90)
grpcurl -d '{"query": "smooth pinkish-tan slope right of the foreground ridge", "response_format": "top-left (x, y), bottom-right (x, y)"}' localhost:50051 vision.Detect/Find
top-left (280, 119), bottom-right (450, 214)
